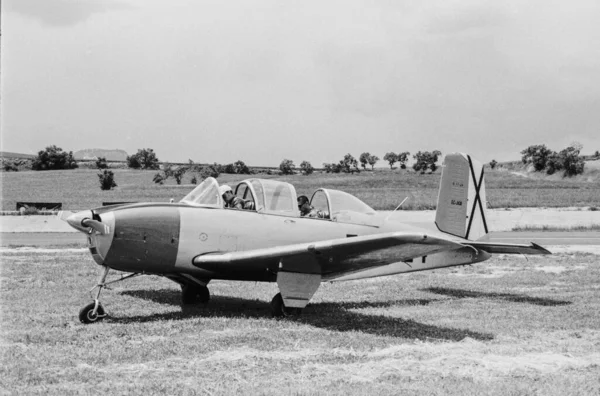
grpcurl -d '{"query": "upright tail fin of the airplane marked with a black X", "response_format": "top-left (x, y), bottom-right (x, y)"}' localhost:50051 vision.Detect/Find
top-left (435, 153), bottom-right (488, 240)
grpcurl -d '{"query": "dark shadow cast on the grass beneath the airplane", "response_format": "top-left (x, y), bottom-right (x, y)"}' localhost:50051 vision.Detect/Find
top-left (116, 289), bottom-right (494, 341)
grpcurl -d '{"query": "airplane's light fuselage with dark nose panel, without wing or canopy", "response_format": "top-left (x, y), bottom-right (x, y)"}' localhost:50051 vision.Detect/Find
top-left (74, 203), bottom-right (489, 281)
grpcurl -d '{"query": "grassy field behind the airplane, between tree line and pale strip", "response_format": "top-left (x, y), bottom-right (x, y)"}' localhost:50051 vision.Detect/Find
top-left (0, 165), bottom-right (600, 210)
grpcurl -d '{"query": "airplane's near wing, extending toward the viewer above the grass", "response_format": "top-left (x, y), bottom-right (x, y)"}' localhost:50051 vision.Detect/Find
top-left (193, 232), bottom-right (465, 275)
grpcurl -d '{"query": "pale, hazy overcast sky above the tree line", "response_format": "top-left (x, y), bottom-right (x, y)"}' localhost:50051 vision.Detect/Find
top-left (0, 0), bottom-right (600, 167)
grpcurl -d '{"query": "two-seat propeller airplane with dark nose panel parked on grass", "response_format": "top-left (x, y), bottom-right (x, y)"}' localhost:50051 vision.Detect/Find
top-left (61, 153), bottom-right (551, 323)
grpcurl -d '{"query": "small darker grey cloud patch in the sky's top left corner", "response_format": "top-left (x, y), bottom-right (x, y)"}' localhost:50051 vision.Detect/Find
top-left (5, 0), bottom-right (132, 27)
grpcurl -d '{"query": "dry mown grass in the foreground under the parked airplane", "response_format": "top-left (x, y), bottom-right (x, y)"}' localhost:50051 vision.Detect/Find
top-left (0, 248), bottom-right (600, 395)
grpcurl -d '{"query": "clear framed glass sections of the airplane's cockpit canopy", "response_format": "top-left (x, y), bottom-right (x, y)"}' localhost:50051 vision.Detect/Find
top-left (180, 177), bottom-right (376, 225)
